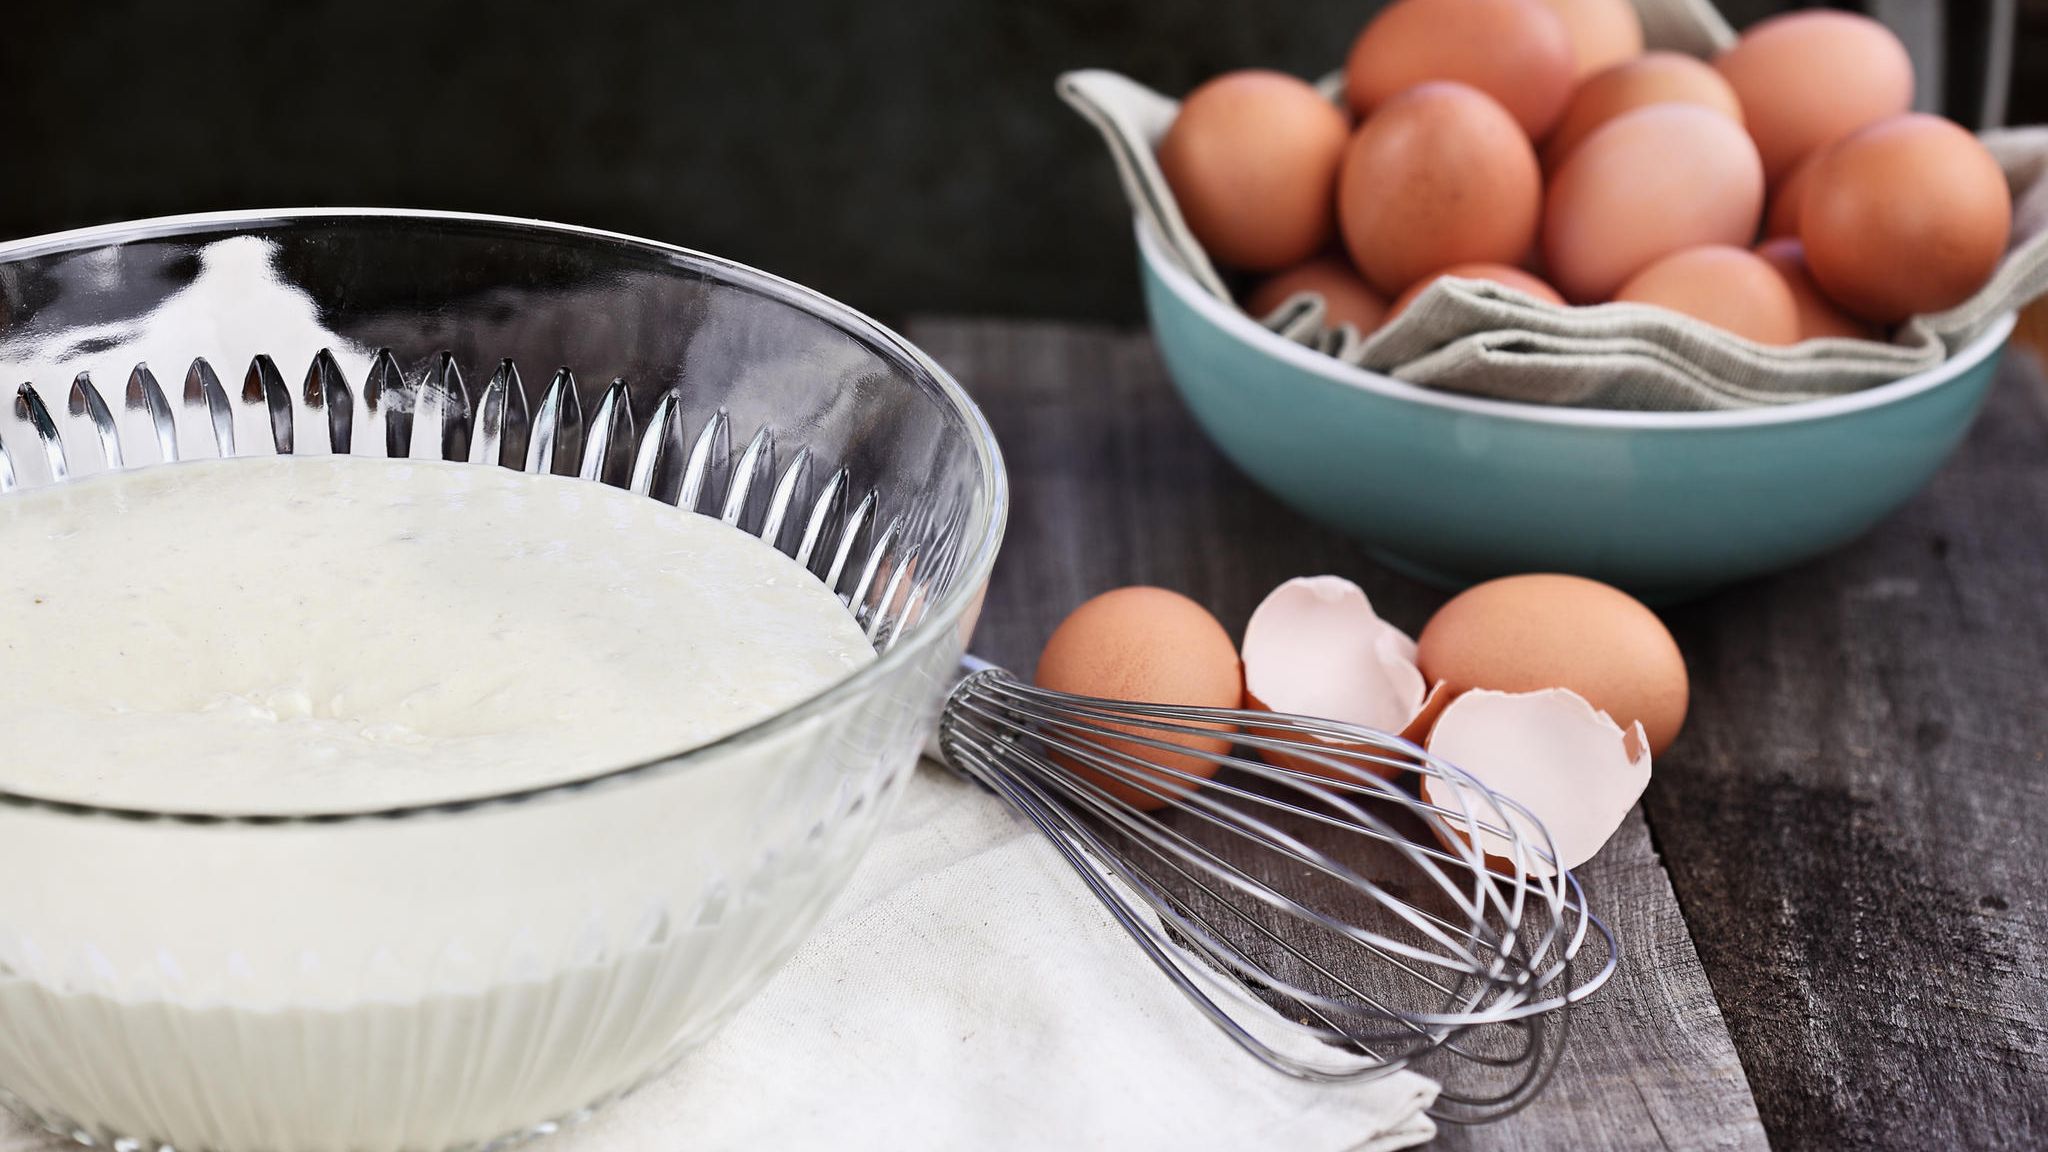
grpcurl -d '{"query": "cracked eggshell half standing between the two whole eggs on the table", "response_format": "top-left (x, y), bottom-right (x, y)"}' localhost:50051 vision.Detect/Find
top-left (1241, 576), bottom-right (1446, 777)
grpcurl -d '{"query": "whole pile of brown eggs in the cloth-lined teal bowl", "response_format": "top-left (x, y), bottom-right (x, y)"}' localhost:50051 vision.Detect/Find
top-left (1159, 0), bottom-right (2011, 344)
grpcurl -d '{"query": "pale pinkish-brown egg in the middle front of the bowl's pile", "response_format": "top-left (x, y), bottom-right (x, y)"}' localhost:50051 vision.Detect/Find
top-left (1542, 105), bottom-right (1763, 303)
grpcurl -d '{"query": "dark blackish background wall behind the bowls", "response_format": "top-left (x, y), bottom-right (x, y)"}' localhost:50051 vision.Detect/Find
top-left (0, 0), bottom-right (2048, 320)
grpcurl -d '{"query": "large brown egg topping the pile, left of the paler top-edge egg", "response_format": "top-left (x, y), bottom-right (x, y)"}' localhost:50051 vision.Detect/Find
top-left (1343, 0), bottom-right (1577, 139)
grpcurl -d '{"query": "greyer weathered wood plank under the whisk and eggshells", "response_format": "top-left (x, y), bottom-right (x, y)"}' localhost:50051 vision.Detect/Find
top-left (911, 320), bottom-right (1763, 1150)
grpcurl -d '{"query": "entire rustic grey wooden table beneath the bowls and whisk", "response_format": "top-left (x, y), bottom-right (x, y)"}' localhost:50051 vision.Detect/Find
top-left (909, 320), bottom-right (2048, 1150)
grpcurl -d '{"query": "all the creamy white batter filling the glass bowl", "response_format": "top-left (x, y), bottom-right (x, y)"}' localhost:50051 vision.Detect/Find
top-left (0, 457), bottom-right (874, 1152)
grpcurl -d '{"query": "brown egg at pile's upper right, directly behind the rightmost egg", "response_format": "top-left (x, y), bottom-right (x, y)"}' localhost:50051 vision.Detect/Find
top-left (1714, 10), bottom-right (1913, 184)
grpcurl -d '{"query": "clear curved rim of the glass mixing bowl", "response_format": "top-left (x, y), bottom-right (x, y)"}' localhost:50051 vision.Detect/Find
top-left (0, 207), bottom-right (1010, 826)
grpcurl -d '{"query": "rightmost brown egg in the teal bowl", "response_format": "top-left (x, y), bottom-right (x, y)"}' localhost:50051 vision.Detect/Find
top-left (1798, 115), bottom-right (2013, 324)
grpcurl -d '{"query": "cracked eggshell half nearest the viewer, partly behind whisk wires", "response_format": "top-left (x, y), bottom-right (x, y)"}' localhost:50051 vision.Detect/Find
top-left (1421, 689), bottom-right (1651, 875)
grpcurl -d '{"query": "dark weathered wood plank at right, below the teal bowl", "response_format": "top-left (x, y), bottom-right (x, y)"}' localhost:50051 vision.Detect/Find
top-left (1649, 353), bottom-right (2048, 1148)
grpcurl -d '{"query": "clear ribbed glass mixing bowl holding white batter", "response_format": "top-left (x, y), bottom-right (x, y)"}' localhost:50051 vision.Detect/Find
top-left (0, 211), bottom-right (1006, 1152)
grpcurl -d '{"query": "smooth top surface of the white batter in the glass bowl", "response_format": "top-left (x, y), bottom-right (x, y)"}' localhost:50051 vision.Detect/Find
top-left (0, 457), bottom-right (874, 812)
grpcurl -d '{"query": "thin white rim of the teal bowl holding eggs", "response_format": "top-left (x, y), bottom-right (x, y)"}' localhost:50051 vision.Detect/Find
top-left (1133, 219), bottom-right (2019, 430)
